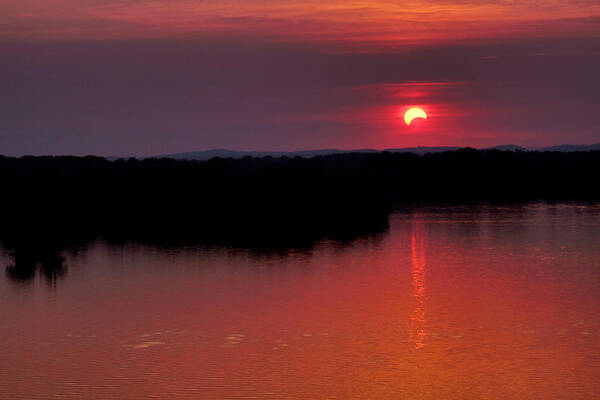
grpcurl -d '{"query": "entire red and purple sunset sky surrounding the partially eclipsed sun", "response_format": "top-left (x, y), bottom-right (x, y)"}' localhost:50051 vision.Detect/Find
top-left (0, 0), bottom-right (600, 156)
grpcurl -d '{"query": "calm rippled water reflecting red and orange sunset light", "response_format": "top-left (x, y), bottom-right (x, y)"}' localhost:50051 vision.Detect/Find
top-left (0, 204), bottom-right (600, 399)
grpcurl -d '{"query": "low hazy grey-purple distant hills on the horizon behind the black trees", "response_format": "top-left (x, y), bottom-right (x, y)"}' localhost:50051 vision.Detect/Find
top-left (148, 143), bottom-right (600, 161)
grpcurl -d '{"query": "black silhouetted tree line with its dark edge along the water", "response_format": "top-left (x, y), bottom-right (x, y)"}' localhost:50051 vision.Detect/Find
top-left (0, 148), bottom-right (600, 278)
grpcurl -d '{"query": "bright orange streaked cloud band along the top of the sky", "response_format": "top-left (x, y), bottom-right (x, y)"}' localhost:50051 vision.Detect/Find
top-left (0, 0), bottom-right (600, 46)
